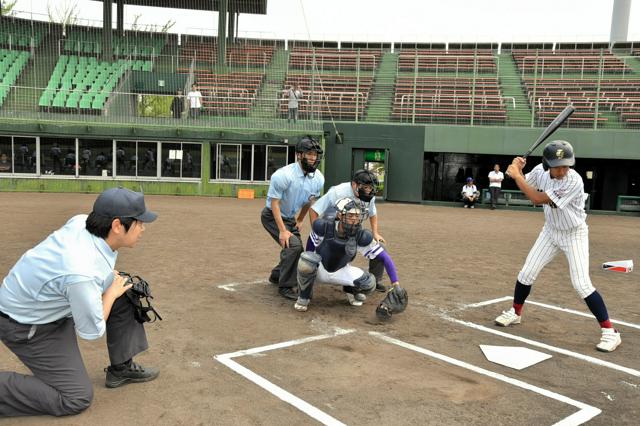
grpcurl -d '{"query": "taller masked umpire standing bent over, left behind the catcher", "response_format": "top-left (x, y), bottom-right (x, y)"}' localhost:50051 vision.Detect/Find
top-left (260, 136), bottom-right (324, 300)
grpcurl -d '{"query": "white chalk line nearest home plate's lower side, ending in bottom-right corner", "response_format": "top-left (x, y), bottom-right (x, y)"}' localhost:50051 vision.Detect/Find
top-left (369, 331), bottom-right (602, 426)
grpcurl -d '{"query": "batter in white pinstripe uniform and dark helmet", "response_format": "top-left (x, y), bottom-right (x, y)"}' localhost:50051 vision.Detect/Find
top-left (495, 141), bottom-right (621, 352)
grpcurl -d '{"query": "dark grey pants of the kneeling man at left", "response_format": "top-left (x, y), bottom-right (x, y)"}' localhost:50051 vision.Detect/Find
top-left (0, 296), bottom-right (149, 417)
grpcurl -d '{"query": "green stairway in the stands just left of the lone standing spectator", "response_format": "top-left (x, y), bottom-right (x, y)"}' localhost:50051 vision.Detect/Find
top-left (247, 49), bottom-right (289, 119)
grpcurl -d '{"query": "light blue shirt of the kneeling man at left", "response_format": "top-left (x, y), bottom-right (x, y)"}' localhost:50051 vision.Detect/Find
top-left (0, 215), bottom-right (118, 339)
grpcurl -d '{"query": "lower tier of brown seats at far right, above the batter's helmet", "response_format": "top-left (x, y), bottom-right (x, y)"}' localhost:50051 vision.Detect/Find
top-left (524, 78), bottom-right (640, 127)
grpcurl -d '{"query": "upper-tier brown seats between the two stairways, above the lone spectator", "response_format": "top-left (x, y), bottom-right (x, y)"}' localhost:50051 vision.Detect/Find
top-left (289, 47), bottom-right (382, 72)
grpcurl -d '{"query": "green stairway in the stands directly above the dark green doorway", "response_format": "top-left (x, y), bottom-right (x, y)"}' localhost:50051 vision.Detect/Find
top-left (364, 52), bottom-right (398, 122)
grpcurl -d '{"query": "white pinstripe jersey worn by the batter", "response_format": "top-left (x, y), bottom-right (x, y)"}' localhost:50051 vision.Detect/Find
top-left (525, 164), bottom-right (587, 231)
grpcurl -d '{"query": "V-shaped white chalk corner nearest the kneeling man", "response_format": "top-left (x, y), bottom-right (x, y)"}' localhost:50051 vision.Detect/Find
top-left (214, 328), bottom-right (355, 426)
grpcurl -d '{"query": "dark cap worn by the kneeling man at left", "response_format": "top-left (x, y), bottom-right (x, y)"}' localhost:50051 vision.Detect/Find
top-left (93, 188), bottom-right (158, 223)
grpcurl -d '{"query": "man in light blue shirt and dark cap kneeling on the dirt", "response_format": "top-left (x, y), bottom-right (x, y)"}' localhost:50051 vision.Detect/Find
top-left (0, 188), bottom-right (159, 417)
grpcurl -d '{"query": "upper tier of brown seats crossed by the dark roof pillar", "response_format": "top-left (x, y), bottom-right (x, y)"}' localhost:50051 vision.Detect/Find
top-left (180, 41), bottom-right (275, 67)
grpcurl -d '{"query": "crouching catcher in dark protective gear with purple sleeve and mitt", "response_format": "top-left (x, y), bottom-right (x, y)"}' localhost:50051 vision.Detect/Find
top-left (294, 198), bottom-right (407, 318)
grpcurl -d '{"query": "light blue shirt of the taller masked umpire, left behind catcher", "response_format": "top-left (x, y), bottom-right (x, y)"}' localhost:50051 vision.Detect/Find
top-left (267, 161), bottom-right (324, 219)
